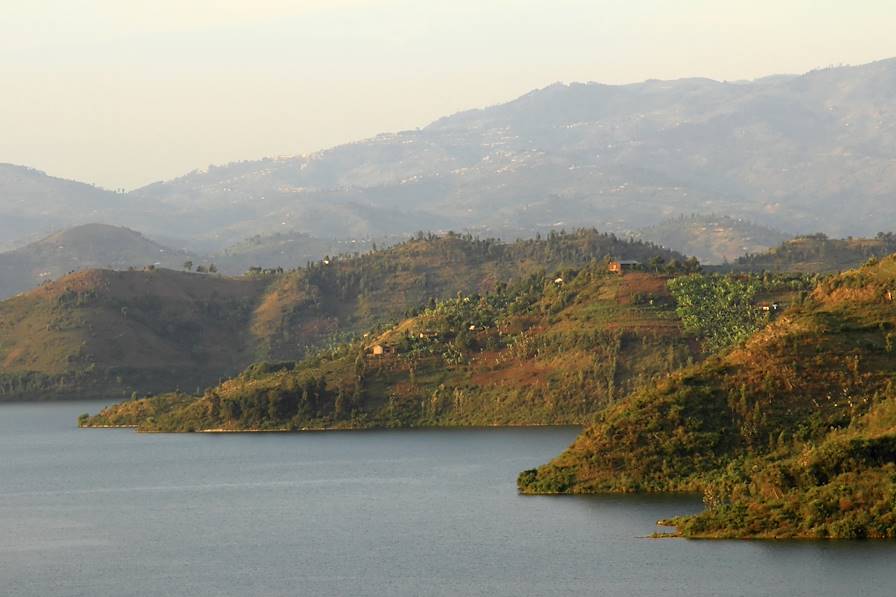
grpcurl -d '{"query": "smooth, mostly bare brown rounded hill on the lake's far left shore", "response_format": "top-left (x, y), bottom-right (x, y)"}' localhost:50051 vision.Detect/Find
top-left (0, 269), bottom-right (265, 399)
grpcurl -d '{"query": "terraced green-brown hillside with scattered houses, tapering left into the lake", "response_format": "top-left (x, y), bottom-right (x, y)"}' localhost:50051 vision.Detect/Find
top-left (85, 263), bottom-right (699, 431)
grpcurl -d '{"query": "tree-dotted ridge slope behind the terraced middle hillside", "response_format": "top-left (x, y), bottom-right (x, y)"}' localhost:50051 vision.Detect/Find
top-left (252, 230), bottom-right (697, 360)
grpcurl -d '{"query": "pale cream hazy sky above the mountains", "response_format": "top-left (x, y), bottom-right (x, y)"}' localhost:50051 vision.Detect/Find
top-left (0, 0), bottom-right (896, 189)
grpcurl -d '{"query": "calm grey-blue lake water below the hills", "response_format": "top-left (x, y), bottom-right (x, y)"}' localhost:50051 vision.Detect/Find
top-left (0, 403), bottom-right (896, 597)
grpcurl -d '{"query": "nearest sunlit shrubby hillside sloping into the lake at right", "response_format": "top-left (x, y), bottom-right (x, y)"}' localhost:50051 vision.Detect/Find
top-left (519, 257), bottom-right (896, 537)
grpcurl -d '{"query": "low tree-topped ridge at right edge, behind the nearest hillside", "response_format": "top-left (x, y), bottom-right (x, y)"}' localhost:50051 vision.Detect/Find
top-left (724, 232), bottom-right (896, 273)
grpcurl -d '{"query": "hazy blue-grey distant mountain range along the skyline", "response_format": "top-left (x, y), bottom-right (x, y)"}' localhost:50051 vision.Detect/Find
top-left (0, 59), bottom-right (896, 252)
